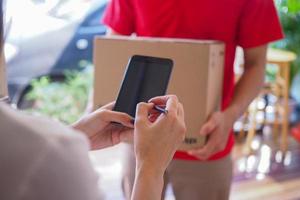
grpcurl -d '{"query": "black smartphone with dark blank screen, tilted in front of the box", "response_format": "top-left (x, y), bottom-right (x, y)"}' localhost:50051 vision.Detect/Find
top-left (114, 55), bottom-right (173, 117)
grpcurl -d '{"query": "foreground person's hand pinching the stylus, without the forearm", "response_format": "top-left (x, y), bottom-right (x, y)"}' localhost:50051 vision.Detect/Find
top-left (134, 95), bottom-right (186, 174)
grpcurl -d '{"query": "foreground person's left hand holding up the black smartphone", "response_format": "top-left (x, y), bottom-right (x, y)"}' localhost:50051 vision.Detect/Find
top-left (72, 102), bottom-right (133, 150)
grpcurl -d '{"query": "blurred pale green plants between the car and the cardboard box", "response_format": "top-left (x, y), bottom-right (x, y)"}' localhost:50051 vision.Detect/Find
top-left (25, 67), bottom-right (93, 124)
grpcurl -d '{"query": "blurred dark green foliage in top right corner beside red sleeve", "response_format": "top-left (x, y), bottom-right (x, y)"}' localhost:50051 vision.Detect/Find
top-left (273, 0), bottom-right (300, 81)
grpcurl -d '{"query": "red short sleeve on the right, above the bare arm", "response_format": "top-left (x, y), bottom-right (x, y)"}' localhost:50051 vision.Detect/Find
top-left (237, 0), bottom-right (283, 48)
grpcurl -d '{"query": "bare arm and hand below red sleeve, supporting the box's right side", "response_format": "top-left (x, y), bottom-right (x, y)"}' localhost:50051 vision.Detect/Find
top-left (189, 45), bottom-right (267, 159)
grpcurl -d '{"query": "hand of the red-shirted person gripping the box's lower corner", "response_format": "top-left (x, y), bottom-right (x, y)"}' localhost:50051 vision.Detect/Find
top-left (188, 111), bottom-right (234, 160)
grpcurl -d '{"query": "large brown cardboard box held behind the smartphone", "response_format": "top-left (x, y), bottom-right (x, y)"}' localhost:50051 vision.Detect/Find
top-left (94, 36), bottom-right (224, 150)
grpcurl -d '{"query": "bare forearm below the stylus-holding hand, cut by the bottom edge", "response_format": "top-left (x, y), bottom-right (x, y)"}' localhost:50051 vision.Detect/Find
top-left (131, 165), bottom-right (164, 200)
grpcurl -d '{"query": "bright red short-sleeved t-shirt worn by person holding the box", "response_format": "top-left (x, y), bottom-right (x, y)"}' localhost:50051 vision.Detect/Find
top-left (103, 0), bottom-right (283, 160)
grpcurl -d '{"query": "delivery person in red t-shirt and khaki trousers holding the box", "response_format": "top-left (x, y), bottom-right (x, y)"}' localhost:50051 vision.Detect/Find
top-left (104, 0), bottom-right (283, 200)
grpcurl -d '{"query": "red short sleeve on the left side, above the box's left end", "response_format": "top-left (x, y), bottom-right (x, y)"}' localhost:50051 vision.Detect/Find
top-left (103, 0), bottom-right (135, 35)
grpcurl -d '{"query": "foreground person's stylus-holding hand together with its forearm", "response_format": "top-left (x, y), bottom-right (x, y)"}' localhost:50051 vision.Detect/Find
top-left (132, 95), bottom-right (186, 200)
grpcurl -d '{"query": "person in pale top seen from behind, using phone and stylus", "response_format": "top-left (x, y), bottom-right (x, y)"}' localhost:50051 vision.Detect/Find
top-left (0, 0), bottom-right (185, 200)
